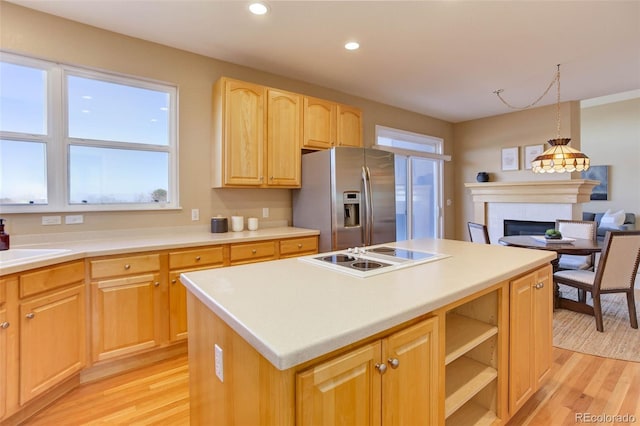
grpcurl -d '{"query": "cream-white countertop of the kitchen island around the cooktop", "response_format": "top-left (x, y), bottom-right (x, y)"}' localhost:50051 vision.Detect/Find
top-left (181, 239), bottom-right (556, 370)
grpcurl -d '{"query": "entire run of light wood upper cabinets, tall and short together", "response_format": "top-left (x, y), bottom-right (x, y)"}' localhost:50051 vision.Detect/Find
top-left (212, 77), bottom-right (362, 188)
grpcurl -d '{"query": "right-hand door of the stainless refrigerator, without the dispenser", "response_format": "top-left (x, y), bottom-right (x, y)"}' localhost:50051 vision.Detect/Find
top-left (364, 149), bottom-right (396, 245)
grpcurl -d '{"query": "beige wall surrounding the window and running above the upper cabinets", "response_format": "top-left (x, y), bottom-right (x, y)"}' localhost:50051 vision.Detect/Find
top-left (0, 1), bottom-right (455, 237)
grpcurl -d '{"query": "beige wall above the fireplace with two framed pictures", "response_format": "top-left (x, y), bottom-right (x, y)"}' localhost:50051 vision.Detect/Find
top-left (453, 100), bottom-right (581, 240)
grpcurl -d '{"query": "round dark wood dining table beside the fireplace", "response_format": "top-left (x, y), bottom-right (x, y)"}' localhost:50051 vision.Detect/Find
top-left (498, 235), bottom-right (603, 312)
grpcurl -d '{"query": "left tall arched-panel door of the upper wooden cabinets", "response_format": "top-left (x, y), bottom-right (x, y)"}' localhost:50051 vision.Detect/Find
top-left (224, 80), bottom-right (265, 186)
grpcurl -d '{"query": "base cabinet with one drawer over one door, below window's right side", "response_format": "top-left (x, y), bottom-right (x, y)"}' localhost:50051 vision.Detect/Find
top-left (89, 254), bottom-right (166, 361)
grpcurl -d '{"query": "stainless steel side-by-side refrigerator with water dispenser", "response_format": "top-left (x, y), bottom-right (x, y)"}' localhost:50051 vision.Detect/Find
top-left (293, 147), bottom-right (396, 252)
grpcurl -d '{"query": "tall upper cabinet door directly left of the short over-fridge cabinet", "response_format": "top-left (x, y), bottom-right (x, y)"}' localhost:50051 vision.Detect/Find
top-left (266, 89), bottom-right (302, 188)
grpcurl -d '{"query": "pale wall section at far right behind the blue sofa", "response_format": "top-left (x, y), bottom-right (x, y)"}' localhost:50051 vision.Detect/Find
top-left (582, 98), bottom-right (640, 221)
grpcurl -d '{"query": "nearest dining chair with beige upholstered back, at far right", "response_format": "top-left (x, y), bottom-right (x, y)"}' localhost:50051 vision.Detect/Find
top-left (553, 231), bottom-right (640, 332)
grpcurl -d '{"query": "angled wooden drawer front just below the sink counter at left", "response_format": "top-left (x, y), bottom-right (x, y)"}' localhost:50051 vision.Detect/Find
top-left (20, 262), bottom-right (84, 298)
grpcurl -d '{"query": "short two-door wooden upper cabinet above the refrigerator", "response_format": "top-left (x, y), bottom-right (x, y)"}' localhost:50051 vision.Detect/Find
top-left (302, 96), bottom-right (362, 149)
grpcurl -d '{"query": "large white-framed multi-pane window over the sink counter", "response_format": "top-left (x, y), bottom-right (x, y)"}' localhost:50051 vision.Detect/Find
top-left (0, 52), bottom-right (179, 213)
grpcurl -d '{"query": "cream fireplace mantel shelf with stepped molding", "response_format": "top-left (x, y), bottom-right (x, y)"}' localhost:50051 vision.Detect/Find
top-left (464, 179), bottom-right (600, 204)
